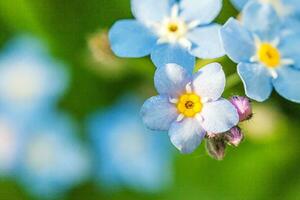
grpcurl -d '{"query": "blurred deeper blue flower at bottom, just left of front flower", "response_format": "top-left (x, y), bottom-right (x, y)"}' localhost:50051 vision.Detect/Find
top-left (87, 97), bottom-right (173, 192)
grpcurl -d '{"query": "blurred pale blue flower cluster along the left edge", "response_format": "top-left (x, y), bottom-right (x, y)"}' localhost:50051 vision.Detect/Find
top-left (0, 37), bottom-right (90, 198)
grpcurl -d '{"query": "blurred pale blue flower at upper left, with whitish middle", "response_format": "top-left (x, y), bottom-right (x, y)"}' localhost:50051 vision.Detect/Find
top-left (0, 37), bottom-right (68, 113)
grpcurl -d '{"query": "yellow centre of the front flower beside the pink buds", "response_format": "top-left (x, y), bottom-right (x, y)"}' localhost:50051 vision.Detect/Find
top-left (177, 93), bottom-right (203, 117)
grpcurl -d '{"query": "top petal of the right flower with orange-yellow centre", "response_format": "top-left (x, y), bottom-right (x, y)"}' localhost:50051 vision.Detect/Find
top-left (242, 1), bottom-right (281, 40)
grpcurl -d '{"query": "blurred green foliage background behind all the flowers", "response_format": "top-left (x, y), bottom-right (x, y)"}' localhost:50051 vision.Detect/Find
top-left (0, 0), bottom-right (300, 200)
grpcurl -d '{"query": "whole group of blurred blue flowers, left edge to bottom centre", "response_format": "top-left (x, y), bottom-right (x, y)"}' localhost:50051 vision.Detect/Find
top-left (0, 36), bottom-right (173, 195)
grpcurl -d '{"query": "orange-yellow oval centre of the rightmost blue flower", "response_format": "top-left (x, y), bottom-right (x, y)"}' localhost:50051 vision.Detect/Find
top-left (257, 43), bottom-right (281, 68)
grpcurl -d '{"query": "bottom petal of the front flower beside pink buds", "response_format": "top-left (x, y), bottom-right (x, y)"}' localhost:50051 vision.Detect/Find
top-left (169, 118), bottom-right (205, 154)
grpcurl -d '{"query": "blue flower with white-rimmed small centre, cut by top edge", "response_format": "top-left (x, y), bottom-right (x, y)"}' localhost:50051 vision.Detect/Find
top-left (109, 0), bottom-right (224, 71)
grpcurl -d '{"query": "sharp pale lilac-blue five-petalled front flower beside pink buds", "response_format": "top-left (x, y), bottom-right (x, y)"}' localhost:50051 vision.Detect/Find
top-left (141, 63), bottom-right (239, 153)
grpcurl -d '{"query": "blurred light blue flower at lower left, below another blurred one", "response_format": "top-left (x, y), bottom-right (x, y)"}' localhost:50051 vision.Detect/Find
top-left (18, 114), bottom-right (90, 197)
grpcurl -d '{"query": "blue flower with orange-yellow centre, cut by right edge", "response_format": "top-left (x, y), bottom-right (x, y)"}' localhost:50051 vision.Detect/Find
top-left (221, 17), bottom-right (300, 103)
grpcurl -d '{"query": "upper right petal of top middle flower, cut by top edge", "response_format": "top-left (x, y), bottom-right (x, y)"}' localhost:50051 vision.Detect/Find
top-left (180, 0), bottom-right (222, 24)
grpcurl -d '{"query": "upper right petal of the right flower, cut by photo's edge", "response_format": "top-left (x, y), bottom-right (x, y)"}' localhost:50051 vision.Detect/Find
top-left (279, 34), bottom-right (300, 69)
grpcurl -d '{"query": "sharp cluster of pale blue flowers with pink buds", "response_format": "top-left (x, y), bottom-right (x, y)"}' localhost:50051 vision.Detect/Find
top-left (109, 0), bottom-right (300, 159)
